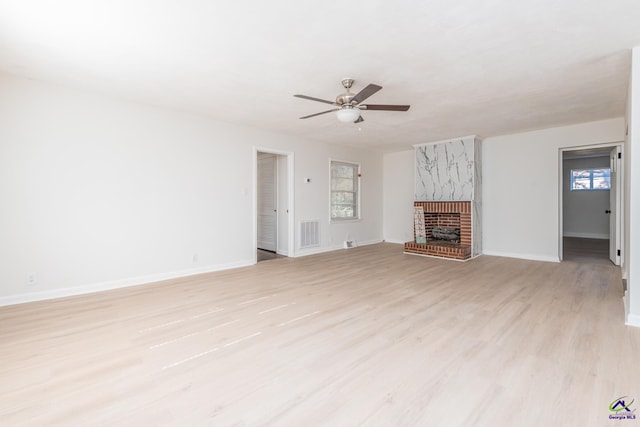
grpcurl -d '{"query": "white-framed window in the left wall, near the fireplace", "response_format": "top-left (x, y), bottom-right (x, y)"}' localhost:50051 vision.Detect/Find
top-left (331, 160), bottom-right (360, 221)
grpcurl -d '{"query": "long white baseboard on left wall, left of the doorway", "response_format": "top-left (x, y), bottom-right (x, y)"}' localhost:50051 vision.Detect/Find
top-left (0, 261), bottom-right (254, 307)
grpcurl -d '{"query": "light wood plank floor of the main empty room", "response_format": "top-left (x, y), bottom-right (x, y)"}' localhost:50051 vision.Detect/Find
top-left (0, 244), bottom-right (640, 427)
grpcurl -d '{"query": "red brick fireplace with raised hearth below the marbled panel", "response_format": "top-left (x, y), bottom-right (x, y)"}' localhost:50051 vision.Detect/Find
top-left (404, 201), bottom-right (473, 260)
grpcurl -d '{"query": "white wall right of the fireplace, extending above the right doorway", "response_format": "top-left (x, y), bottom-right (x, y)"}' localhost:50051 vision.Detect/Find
top-left (482, 118), bottom-right (624, 261)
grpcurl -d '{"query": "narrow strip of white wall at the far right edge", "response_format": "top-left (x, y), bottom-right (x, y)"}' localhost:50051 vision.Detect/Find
top-left (622, 47), bottom-right (640, 327)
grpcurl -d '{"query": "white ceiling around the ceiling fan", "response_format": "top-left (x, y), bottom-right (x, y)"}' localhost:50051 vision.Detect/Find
top-left (0, 0), bottom-right (640, 151)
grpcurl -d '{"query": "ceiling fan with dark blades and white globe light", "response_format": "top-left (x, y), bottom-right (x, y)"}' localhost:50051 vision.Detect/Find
top-left (293, 79), bottom-right (410, 123)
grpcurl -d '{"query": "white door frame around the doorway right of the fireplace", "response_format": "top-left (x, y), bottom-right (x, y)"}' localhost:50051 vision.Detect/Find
top-left (558, 141), bottom-right (625, 265)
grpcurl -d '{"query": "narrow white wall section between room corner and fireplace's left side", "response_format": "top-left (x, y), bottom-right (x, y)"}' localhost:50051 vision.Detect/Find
top-left (382, 150), bottom-right (415, 243)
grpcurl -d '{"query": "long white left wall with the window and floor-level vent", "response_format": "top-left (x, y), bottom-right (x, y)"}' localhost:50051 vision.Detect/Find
top-left (0, 75), bottom-right (382, 305)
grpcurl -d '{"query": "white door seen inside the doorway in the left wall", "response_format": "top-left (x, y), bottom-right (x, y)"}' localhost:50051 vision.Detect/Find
top-left (258, 155), bottom-right (278, 252)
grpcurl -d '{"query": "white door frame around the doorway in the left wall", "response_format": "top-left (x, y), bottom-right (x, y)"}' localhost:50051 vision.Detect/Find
top-left (253, 145), bottom-right (295, 264)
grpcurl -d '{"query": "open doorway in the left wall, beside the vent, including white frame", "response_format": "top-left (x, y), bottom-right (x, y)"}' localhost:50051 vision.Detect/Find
top-left (254, 148), bottom-right (293, 262)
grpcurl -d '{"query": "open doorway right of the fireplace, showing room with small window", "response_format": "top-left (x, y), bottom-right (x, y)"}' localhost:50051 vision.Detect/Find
top-left (559, 144), bottom-right (622, 265)
